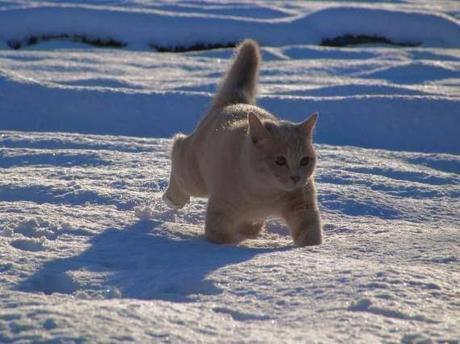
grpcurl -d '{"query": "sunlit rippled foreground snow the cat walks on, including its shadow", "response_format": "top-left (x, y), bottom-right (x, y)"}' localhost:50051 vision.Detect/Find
top-left (0, 132), bottom-right (460, 342)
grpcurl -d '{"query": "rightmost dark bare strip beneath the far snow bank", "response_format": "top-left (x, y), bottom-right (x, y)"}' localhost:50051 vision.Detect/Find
top-left (320, 34), bottom-right (422, 47)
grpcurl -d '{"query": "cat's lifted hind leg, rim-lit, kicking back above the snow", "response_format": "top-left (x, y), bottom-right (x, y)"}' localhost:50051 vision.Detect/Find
top-left (163, 134), bottom-right (190, 209)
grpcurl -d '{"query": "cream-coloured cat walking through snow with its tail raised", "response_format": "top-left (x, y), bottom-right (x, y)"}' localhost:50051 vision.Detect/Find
top-left (163, 40), bottom-right (322, 246)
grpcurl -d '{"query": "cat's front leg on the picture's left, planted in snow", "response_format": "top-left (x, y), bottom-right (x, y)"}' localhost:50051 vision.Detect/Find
top-left (205, 198), bottom-right (240, 244)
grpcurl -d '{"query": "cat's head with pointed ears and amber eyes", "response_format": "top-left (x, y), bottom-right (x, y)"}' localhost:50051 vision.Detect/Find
top-left (248, 113), bottom-right (318, 191)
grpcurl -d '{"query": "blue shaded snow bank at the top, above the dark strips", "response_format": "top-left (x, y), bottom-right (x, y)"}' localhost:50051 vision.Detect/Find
top-left (0, 4), bottom-right (460, 49)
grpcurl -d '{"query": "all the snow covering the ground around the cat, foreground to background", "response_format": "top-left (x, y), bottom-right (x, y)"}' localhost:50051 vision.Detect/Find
top-left (0, 0), bottom-right (460, 343)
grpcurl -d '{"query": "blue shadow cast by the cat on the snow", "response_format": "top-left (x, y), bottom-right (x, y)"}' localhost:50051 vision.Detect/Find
top-left (18, 221), bottom-right (288, 302)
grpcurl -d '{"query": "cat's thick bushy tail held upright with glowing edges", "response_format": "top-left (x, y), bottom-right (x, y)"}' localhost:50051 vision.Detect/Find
top-left (212, 39), bottom-right (260, 109)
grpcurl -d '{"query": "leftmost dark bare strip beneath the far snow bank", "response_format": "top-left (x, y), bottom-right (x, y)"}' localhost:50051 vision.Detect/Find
top-left (7, 34), bottom-right (126, 50)
